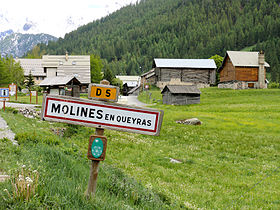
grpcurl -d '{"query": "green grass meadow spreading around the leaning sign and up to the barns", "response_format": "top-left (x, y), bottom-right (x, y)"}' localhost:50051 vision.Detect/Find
top-left (0, 88), bottom-right (280, 209)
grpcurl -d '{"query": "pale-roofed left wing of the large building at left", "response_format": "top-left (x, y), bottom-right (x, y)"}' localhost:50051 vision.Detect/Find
top-left (15, 58), bottom-right (44, 85)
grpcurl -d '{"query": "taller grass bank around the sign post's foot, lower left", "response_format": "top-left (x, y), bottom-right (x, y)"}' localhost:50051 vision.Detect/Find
top-left (0, 112), bottom-right (175, 209)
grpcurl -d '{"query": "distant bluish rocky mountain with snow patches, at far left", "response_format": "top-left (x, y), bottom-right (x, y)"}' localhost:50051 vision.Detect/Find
top-left (0, 32), bottom-right (57, 57)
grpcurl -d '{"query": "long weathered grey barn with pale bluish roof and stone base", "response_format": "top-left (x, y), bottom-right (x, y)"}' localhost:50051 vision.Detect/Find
top-left (150, 58), bottom-right (216, 89)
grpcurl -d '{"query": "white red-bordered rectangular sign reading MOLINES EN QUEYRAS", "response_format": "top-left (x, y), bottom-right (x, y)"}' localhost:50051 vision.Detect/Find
top-left (42, 95), bottom-right (163, 135)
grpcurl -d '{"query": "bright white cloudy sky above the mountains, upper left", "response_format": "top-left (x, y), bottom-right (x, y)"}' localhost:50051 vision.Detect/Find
top-left (0, 0), bottom-right (137, 37)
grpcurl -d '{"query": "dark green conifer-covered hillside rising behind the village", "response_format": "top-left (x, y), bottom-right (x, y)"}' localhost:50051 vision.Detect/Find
top-left (34, 0), bottom-right (280, 81)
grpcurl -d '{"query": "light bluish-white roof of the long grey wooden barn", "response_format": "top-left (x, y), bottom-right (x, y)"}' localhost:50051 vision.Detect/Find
top-left (153, 58), bottom-right (217, 69)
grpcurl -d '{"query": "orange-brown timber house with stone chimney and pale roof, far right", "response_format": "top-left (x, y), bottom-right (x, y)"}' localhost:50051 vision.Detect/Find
top-left (218, 51), bottom-right (269, 89)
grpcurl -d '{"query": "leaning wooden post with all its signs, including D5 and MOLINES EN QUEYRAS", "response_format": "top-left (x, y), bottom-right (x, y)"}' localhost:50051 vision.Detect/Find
top-left (41, 81), bottom-right (163, 197)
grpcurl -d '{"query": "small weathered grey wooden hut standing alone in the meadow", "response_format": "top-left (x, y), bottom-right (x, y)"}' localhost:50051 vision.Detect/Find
top-left (161, 85), bottom-right (201, 105)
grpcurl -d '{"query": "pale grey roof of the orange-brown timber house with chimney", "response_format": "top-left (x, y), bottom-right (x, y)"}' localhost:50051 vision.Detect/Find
top-left (227, 51), bottom-right (270, 67)
